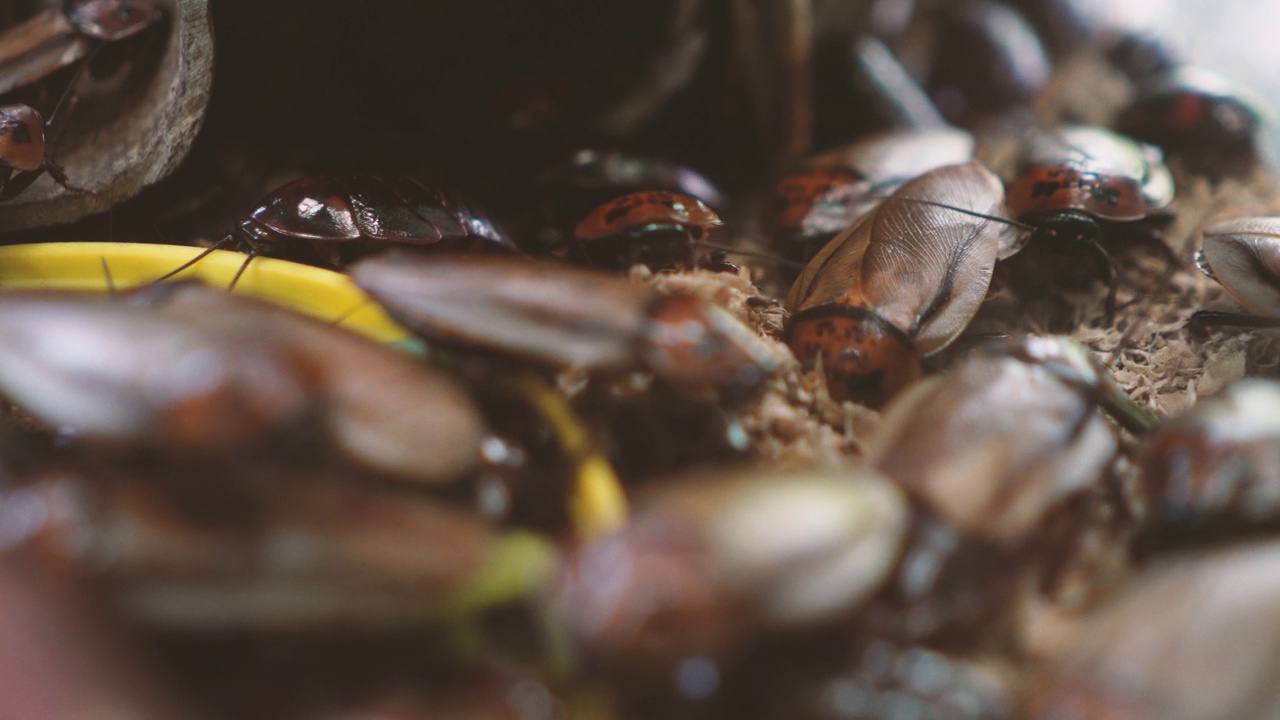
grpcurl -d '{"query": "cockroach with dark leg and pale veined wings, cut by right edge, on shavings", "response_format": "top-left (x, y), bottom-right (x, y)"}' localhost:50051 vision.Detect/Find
top-left (1192, 217), bottom-right (1280, 328)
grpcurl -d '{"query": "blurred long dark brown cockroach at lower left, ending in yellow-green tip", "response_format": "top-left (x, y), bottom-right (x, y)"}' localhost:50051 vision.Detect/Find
top-left (0, 465), bottom-right (556, 632)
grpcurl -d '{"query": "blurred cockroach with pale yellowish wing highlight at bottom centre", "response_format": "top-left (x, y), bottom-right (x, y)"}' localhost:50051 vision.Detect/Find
top-left (558, 470), bottom-right (909, 673)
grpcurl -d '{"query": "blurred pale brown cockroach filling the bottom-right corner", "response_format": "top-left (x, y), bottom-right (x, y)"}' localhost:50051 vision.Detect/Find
top-left (1019, 541), bottom-right (1280, 720)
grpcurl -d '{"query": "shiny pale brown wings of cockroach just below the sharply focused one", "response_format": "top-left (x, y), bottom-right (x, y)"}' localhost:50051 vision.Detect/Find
top-left (867, 356), bottom-right (1117, 546)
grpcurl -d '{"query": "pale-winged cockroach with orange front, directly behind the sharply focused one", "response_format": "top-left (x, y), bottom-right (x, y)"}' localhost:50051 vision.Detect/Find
top-left (762, 128), bottom-right (974, 261)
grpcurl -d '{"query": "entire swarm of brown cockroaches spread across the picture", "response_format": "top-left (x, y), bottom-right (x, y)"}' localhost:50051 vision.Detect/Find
top-left (0, 0), bottom-right (1280, 720)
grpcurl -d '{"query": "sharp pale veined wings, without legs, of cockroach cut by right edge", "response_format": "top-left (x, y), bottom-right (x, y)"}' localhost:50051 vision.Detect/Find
top-left (1204, 218), bottom-right (1280, 316)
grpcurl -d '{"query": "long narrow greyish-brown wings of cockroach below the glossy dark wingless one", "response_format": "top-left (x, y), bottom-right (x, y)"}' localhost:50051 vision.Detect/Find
top-left (352, 252), bottom-right (652, 369)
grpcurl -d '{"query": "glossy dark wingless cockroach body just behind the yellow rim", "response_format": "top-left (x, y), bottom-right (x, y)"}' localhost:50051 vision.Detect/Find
top-left (241, 176), bottom-right (515, 256)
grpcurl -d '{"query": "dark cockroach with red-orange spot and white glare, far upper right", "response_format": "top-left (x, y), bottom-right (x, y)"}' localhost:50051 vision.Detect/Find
top-left (1115, 65), bottom-right (1274, 177)
